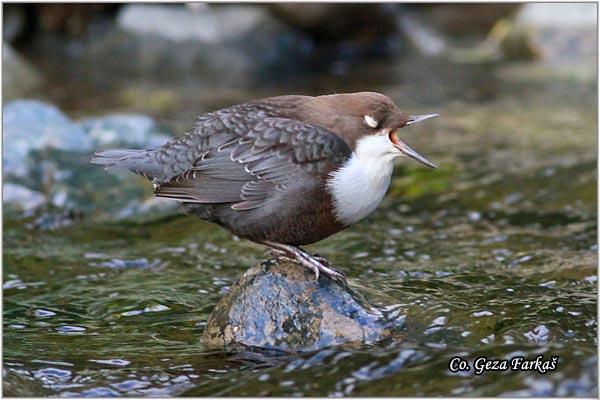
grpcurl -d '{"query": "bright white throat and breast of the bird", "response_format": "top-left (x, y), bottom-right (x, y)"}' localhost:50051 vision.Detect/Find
top-left (327, 135), bottom-right (397, 225)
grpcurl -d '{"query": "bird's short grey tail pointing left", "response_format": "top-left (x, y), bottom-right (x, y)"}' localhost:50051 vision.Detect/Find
top-left (90, 149), bottom-right (160, 178)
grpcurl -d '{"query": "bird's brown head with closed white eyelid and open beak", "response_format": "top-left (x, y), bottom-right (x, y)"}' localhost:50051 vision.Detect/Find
top-left (316, 92), bottom-right (438, 168)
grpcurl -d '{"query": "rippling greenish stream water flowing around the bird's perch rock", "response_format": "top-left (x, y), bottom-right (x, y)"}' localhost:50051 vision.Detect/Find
top-left (3, 26), bottom-right (597, 397)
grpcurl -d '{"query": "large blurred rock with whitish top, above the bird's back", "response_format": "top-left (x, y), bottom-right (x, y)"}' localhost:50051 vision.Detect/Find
top-left (86, 4), bottom-right (310, 86)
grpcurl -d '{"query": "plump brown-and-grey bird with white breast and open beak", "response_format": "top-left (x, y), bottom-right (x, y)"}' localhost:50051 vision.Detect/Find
top-left (91, 92), bottom-right (439, 281)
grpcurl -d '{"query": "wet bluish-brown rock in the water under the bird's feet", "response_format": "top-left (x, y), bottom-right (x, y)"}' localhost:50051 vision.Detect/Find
top-left (202, 259), bottom-right (403, 351)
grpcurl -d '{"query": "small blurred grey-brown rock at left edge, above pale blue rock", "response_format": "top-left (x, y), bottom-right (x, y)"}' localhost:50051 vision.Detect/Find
top-left (2, 43), bottom-right (42, 100)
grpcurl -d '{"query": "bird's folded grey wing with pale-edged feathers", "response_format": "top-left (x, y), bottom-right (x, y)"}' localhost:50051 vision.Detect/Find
top-left (155, 117), bottom-right (351, 210)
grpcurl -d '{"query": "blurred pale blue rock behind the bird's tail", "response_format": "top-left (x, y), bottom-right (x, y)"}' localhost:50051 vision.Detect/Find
top-left (3, 100), bottom-right (175, 217)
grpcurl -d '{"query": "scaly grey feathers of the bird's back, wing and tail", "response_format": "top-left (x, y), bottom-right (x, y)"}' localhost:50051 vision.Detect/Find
top-left (91, 103), bottom-right (351, 210)
